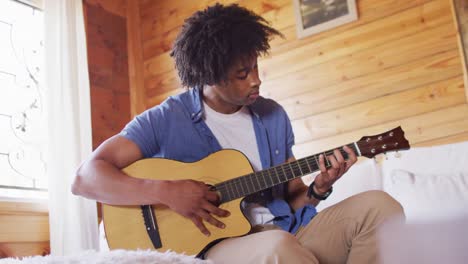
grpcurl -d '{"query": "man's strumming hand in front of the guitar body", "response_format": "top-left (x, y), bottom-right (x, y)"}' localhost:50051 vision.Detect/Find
top-left (166, 180), bottom-right (230, 236)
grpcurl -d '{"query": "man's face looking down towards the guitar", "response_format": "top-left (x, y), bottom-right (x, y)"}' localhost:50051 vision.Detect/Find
top-left (209, 57), bottom-right (261, 109)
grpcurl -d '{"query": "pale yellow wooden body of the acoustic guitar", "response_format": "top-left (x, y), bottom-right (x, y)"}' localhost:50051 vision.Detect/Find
top-left (102, 150), bottom-right (253, 255)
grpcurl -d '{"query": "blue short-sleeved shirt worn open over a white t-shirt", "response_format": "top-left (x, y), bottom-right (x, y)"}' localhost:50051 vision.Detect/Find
top-left (120, 88), bottom-right (315, 232)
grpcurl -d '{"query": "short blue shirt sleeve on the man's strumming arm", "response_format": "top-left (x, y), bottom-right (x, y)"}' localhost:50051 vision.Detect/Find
top-left (120, 108), bottom-right (159, 158)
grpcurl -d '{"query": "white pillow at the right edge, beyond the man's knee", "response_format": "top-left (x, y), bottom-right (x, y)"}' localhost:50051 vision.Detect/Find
top-left (384, 169), bottom-right (468, 222)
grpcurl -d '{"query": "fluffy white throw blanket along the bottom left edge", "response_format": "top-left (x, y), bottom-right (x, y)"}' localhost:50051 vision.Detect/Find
top-left (0, 250), bottom-right (213, 264)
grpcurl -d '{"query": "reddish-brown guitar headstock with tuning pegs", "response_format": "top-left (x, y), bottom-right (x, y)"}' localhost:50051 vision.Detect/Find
top-left (356, 126), bottom-right (410, 158)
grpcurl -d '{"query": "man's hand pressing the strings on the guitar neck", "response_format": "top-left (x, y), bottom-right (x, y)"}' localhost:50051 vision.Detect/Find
top-left (314, 146), bottom-right (357, 195)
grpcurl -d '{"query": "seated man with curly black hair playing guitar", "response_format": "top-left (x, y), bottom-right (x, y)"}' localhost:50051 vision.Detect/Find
top-left (73, 4), bottom-right (402, 263)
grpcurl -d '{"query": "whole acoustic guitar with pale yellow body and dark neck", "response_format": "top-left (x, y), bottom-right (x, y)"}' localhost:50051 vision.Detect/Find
top-left (103, 127), bottom-right (410, 255)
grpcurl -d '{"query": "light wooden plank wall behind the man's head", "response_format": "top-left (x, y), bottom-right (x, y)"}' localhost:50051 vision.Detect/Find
top-left (132, 0), bottom-right (468, 157)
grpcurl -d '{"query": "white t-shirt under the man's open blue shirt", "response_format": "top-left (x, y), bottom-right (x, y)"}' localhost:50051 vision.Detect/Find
top-left (203, 102), bottom-right (274, 226)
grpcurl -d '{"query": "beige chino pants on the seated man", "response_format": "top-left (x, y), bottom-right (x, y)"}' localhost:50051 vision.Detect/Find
top-left (207, 191), bottom-right (404, 264)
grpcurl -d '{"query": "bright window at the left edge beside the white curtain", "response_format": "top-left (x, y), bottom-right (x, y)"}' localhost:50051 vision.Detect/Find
top-left (0, 0), bottom-right (47, 198)
